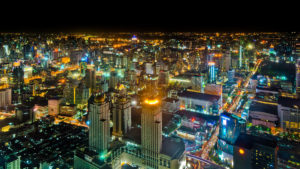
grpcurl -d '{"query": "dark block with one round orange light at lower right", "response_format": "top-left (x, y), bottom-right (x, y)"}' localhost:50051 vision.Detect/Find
top-left (233, 134), bottom-right (278, 169)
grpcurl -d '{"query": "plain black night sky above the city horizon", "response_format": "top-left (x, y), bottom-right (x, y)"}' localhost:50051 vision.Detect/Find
top-left (0, 1), bottom-right (300, 32)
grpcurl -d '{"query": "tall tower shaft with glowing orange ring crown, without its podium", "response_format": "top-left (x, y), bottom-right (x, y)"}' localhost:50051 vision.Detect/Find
top-left (141, 94), bottom-right (162, 168)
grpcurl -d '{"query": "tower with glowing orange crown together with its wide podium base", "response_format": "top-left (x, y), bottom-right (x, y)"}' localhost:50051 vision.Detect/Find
top-left (112, 92), bottom-right (185, 169)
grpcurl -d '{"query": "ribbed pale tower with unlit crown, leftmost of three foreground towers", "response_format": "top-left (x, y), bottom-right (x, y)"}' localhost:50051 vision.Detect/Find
top-left (88, 94), bottom-right (110, 153)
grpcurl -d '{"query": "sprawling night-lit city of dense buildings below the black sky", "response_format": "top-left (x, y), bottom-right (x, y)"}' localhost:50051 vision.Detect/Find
top-left (0, 32), bottom-right (300, 169)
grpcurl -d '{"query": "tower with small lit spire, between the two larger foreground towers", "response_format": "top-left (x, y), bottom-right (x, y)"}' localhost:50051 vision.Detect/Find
top-left (112, 84), bottom-right (131, 137)
